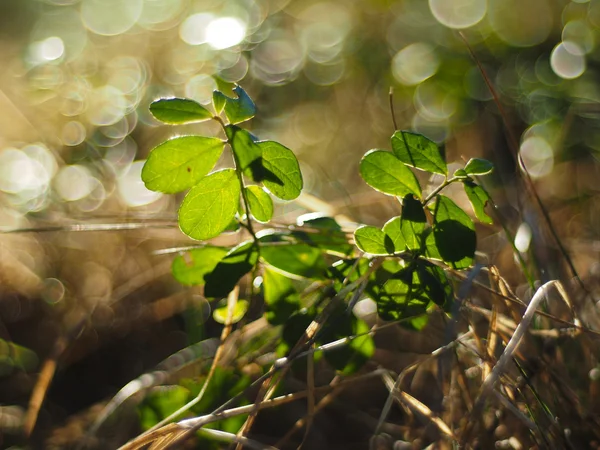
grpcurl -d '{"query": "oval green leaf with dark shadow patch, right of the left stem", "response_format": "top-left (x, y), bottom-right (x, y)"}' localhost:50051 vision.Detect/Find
top-left (257, 141), bottom-right (303, 200)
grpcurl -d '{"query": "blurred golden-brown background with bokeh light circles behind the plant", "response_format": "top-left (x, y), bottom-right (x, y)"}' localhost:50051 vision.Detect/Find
top-left (0, 0), bottom-right (600, 447)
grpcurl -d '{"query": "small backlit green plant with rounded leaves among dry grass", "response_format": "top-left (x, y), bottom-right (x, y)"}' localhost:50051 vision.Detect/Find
top-left (137, 86), bottom-right (493, 442)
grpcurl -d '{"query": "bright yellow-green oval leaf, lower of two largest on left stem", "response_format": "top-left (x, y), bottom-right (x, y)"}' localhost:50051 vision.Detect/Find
top-left (179, 169), bottom-right (240, 240)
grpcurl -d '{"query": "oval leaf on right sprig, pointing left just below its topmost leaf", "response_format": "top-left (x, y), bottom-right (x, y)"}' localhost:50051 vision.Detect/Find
top-left (360, 150), bottom-right (421, 197)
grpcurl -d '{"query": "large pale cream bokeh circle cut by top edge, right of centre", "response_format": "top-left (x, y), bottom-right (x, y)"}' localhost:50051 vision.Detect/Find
top-left (429, 0), bottom-right (487, 29)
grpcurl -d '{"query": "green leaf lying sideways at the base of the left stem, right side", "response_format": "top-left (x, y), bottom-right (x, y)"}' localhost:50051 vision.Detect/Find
top-left (259, 233), bottom-right (327, 279)
